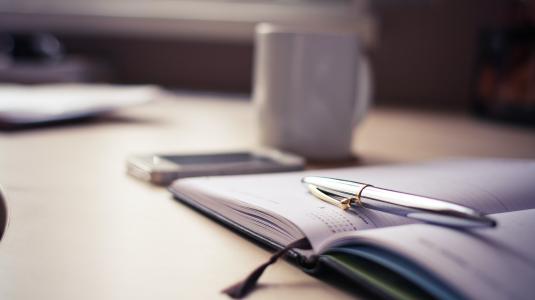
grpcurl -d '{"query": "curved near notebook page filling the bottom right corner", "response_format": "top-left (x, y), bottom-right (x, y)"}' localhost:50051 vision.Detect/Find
top-left (322, 209), bottom-right (535, 300)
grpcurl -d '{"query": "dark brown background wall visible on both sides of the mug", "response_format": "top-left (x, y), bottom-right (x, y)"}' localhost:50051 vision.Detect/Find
top-left (56, 0), bottom-right (510, 107)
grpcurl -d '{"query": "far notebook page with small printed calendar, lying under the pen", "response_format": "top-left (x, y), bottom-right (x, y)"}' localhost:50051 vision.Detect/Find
top-left (172, 160), bottom-right (535, 249)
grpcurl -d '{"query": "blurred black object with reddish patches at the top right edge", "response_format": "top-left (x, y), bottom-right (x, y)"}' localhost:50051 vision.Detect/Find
top-left (474, 1), bottom-right (535, 125)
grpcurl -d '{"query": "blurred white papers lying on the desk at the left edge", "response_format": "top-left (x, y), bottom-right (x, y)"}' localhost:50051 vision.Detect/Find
top-left (0, 84), bottom-right (160, 125)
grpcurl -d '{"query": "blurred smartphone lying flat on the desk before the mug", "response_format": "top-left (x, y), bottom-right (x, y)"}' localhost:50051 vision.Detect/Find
top-left (127, 149), bottom-right (305, 185)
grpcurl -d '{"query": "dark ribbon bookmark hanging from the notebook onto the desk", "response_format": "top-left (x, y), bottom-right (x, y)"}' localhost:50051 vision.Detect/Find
top-left (221, 238), bottom-right (312, 299)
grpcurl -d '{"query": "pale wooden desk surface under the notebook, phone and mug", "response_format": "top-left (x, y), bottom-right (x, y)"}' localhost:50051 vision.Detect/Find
top-left (0, 95), bottom-right (535, 300)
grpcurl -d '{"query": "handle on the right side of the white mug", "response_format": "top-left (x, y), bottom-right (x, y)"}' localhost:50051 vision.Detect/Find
top-left (353, 54), bottom-right (373, 126)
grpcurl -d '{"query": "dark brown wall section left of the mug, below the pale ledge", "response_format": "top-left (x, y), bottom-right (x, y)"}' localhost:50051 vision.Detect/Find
top-left (60, 35), bottom-right (253, 92)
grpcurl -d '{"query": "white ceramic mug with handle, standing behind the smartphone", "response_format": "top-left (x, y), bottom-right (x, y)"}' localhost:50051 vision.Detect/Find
top-left (253, 24), bottom-right (371, 161)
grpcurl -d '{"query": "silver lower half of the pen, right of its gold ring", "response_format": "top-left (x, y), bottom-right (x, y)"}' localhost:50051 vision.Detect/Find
top-left (360, 186), bottom-right (495, 227)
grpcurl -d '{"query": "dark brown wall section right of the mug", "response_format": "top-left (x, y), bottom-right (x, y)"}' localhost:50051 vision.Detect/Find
top-left (370, 0), bottom-right (511, 106)
